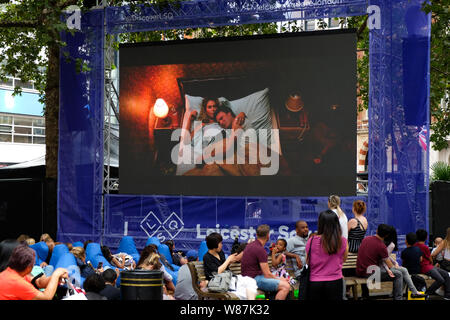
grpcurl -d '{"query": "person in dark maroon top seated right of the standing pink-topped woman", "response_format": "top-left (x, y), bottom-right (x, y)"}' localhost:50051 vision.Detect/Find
top-left (356, 224), bottom-right (403, 300)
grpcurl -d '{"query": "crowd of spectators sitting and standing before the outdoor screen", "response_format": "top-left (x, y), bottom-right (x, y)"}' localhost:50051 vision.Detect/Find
top-left (0, 195), bottom-right (450, 300)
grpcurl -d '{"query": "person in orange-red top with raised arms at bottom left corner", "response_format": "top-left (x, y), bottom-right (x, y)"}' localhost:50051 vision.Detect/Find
top-left (0, 244), bottom-right (68, 300)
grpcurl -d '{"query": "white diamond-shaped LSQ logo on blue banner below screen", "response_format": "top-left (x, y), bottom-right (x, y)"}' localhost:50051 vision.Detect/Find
top-left (140, 211), bottom-right (184, 242)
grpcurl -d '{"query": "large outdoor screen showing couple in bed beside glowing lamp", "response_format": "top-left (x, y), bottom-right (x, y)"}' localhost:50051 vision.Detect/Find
top-left (119, 32), bottom-right (356, 196)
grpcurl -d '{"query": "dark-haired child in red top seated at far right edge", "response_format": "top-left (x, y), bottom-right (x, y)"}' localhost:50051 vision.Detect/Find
top-left (414, 229), bottom-right (450, 300)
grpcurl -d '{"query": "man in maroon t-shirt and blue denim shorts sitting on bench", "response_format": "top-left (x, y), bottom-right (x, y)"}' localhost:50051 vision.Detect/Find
top-left (241, 224), bottom-right (291, 300)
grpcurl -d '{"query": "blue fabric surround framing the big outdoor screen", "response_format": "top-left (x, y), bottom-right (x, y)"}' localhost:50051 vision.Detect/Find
top-left (57, 0), bottom-right (430, 255)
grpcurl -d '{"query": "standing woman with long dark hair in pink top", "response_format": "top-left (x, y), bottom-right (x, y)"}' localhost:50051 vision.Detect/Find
top-left (306, 210), bottom-right (348, 300)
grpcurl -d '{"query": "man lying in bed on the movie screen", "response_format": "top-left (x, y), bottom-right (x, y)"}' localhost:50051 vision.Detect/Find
top-left (185, 105), bottom-right (289, 176)
